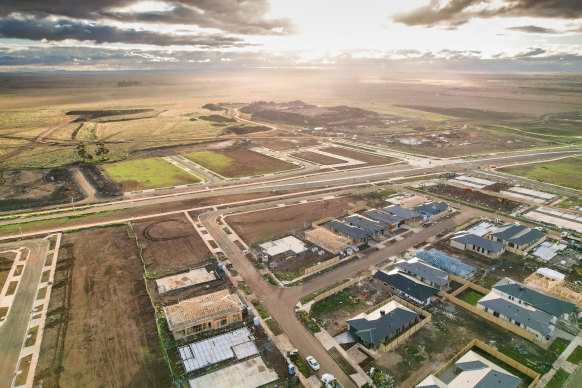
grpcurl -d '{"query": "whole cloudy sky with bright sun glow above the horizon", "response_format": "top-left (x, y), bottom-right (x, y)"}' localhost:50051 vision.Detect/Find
top-left (0, 0), bottom-right (582, 72)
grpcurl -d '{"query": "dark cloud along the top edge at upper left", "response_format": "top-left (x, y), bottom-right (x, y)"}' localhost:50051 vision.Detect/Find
top-left (0, 0), bottom-right (291, 34)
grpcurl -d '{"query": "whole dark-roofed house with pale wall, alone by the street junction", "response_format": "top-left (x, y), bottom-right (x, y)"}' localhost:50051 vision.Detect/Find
top-left (346, 300), bottom-right (422, 348)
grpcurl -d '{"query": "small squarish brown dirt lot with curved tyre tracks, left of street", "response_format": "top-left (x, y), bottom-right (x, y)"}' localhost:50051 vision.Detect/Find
top-left (133, 214), bottom-right (210, 272)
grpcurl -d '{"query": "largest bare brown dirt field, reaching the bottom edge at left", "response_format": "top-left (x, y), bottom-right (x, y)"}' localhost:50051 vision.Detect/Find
top-left (35, 226), bottom-right (171, 387)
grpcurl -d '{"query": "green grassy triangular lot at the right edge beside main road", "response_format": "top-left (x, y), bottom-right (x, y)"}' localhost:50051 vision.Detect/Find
top-left (499, 158), bottom-right (582, 190)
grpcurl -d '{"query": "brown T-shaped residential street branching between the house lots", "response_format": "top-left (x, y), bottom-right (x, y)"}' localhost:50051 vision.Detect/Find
top-left (200, 203), bottom-right (477, 387)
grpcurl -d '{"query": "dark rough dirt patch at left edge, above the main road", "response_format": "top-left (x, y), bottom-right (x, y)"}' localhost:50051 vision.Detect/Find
top-left (0, 168), bottom-right (84, 210)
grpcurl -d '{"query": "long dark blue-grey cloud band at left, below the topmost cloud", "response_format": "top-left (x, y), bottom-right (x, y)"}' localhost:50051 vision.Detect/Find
top-left (0, 18), bottom-right (244, 48)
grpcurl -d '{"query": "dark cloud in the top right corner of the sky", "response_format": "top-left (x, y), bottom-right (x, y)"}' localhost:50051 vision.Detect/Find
top-left (393, 0), bottom-right (582, 26)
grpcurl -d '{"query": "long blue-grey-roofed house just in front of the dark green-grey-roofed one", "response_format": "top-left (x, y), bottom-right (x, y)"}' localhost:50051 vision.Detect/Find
top-left (477, 291), bottom-right (557, 341)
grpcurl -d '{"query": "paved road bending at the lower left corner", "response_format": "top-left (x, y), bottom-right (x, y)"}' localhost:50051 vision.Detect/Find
top-left (0, 240), bottom-right (49, 388)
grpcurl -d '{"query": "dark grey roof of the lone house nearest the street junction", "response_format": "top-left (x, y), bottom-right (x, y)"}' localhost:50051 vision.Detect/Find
top-left (347, 307), bottom-right (418, 345)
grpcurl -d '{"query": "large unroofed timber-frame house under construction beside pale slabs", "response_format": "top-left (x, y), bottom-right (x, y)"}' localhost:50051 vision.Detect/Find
top-left (164, 290), bottom-right (243, 339)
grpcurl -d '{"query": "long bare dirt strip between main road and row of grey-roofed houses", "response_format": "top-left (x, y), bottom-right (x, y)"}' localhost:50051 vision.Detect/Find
top-left (226, 197), bottom-right (365, 245)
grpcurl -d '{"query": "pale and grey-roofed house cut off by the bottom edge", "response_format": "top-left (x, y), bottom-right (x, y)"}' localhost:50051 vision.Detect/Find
top-left (416, 350), bottom-right (521, 388)
